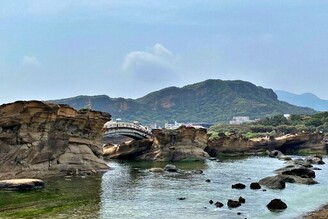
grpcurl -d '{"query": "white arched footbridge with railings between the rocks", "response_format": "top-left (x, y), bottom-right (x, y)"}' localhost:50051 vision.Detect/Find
top-left (103, 121), bottom-right (153, 140)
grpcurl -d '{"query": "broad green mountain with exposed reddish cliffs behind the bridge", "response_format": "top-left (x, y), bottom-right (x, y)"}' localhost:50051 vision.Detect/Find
top-left (50, 80), bottom-right (315, 125)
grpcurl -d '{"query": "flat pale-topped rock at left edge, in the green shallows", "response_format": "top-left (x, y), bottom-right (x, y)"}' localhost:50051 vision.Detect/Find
top-left (0, 179), bottom-right (44, 191)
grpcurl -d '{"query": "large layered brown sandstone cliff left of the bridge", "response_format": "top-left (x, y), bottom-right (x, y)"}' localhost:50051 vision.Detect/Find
top-left (0, 101), bottom-right (110, 178)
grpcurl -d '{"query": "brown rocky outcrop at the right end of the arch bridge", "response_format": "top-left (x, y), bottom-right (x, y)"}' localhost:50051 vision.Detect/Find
top-left (105, 126), bottom-right (208, 161)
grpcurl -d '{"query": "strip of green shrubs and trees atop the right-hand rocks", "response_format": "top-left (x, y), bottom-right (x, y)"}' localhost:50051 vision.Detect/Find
top-left (208, 112), bottom-right (328, 138)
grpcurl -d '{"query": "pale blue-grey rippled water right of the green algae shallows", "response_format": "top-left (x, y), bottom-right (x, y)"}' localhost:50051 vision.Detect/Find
top-left (101, 157), bottom-right (328, 219)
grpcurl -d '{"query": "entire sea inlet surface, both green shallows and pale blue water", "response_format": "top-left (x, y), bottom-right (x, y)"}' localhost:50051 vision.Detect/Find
top-left (0, 157), bottom-right (328, 219)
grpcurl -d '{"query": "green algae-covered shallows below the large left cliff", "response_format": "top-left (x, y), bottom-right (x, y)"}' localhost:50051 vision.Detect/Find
top-left (0, 176), bottom-right (101, 218)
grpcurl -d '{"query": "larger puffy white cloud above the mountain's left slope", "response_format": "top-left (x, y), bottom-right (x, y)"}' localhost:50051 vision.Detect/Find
top-left (122, 43), bottom-right (178, 79)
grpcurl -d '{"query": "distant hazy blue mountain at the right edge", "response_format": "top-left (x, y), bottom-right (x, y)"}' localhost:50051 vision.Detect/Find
top-left (275, 90), bottom-right (328, 111)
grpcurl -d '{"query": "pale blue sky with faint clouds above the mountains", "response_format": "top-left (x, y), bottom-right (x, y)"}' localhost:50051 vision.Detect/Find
top-left (0, 0), bottom-right (328, 104)
